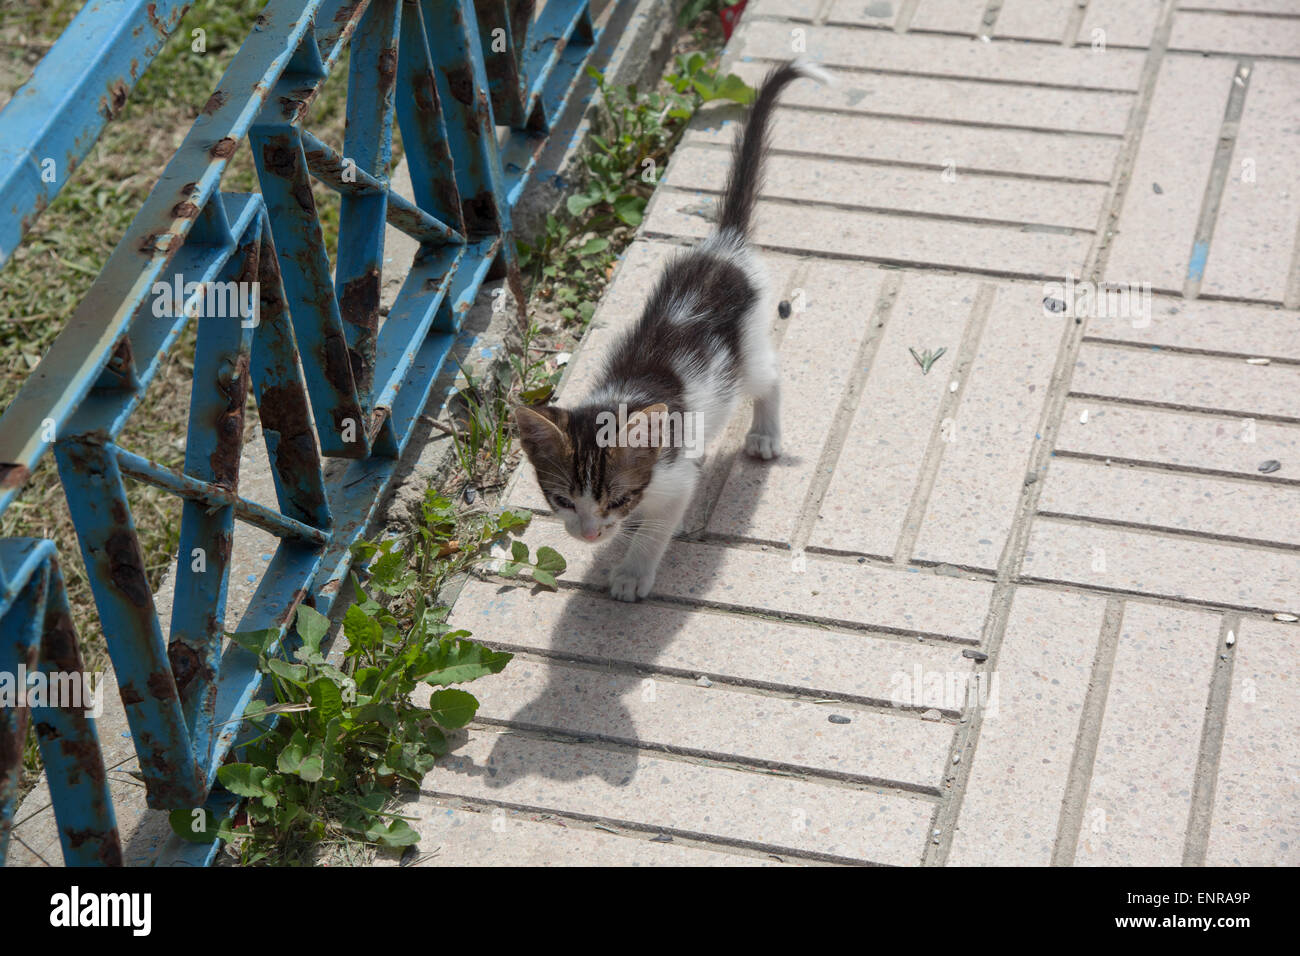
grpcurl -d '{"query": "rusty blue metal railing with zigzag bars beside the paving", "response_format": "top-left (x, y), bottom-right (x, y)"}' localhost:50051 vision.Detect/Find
top-left (0, 0), bottom-right (597, 864)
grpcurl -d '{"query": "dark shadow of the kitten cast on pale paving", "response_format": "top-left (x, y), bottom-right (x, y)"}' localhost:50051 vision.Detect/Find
top-left (467, 451), bottom-right (781, 788)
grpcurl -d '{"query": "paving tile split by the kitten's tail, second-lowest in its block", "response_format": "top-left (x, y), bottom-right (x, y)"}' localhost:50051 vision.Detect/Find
top-left (664, 146), bottom-right (1104, 230)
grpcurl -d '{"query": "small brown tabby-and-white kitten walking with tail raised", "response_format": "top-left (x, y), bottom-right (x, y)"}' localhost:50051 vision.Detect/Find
top-left (514, 61), bottom-right (828, 601)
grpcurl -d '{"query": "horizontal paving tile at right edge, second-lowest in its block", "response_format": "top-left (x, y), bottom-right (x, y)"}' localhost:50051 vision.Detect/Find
top-left (1039, 458), bottom-right (1300, 546)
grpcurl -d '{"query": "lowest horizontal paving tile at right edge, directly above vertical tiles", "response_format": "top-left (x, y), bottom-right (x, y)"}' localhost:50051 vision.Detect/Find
top-left (1023, 518), bottom-right (1300, 613)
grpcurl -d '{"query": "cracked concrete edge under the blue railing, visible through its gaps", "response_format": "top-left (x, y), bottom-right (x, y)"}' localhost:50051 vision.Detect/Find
top-left (7, 0), bottom-right (685, 866)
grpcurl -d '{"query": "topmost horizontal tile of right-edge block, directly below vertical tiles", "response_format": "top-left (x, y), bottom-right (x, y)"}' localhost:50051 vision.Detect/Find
top-left (1087, 297), bottom-right (1300, 362)
